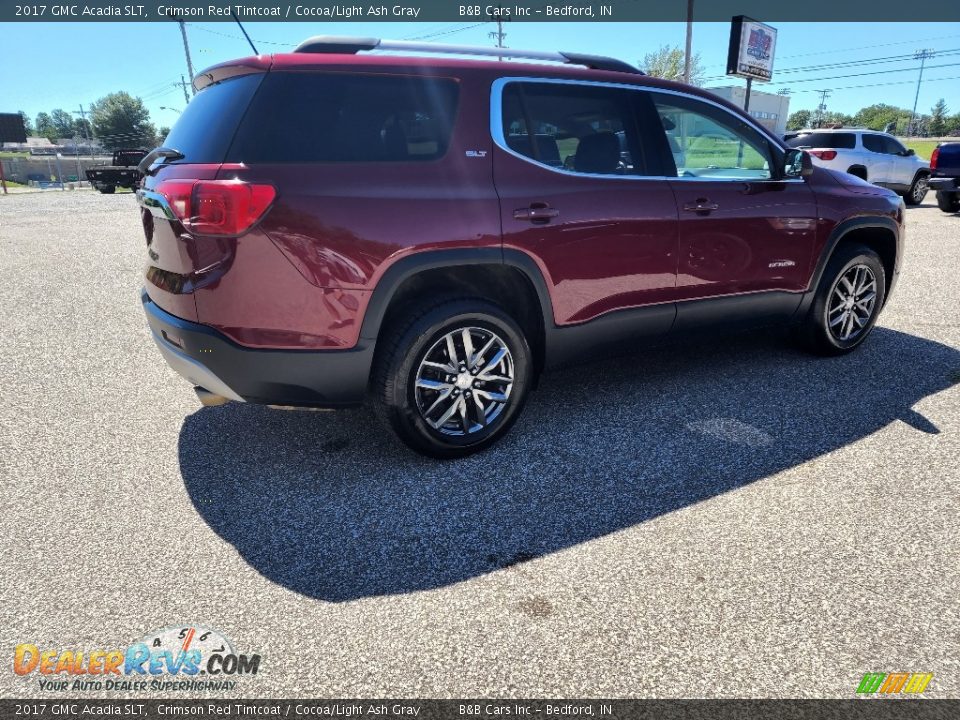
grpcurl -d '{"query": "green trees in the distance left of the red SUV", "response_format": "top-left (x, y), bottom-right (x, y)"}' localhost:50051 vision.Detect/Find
top-left (20, 91), bottom-right (170, 150)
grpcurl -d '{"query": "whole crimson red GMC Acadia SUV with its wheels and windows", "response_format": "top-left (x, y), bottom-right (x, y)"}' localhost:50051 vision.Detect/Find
top-left (138, 38), bottom-right (903, 457)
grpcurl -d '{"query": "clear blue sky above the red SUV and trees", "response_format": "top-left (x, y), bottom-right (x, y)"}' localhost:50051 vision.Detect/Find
top-left (0, 22), bottom-right (960, 128)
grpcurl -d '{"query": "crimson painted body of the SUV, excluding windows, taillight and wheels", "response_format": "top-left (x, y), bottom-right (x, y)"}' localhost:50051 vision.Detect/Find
top-left (139, 47), bottom-right (903, 407)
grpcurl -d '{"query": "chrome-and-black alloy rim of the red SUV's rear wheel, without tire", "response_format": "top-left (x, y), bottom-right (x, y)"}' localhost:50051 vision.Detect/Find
top-left (414, 327), bottom-right (514, 435)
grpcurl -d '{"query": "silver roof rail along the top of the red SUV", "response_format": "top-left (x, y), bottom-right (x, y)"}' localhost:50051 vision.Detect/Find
top-left (294, 35), bottom-right (643, 75)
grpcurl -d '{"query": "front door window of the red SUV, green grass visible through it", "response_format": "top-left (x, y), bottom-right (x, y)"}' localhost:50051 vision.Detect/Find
top-left (652, 93), bottom-right (772, 180)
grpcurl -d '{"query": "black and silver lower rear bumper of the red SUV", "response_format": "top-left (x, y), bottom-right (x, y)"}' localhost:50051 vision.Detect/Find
top-left (141, 291), bottom-right (373, 408)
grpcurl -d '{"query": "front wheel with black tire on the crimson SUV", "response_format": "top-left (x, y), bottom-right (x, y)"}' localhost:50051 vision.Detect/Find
top-left (797, 243), bottom-right (886, 355)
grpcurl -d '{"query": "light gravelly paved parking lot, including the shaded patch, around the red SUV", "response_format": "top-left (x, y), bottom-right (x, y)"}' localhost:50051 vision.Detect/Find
top-left (0, 192), bottom-right (960, 697)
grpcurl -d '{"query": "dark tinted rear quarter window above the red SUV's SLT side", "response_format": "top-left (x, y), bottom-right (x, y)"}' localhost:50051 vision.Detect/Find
top-left (229, 72), bottom-right (458, 163)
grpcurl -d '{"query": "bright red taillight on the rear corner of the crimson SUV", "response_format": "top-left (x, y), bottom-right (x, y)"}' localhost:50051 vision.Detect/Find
top-left (156, 180), bottom-right (277, 235)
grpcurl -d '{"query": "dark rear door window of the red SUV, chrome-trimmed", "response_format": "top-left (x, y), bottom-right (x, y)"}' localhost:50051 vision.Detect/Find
top-left (502, 82), bottom-right (645, 175)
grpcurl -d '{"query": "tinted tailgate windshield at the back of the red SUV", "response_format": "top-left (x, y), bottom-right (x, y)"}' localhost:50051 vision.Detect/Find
top-left (163, 73), bottom-right (264, 163)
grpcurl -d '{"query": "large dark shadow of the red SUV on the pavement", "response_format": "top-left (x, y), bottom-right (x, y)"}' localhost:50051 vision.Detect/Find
top-left (179, 328), bottom-right (960, 602)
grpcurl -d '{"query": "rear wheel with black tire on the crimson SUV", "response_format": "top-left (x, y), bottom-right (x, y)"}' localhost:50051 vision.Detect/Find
top-left (372, 298), bottom-right (533, 459)
